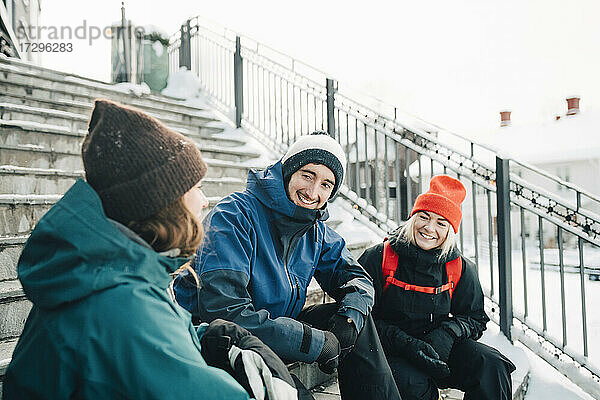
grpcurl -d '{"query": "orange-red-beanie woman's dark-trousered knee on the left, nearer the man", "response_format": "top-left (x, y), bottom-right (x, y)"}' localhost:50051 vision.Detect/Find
top-left (388, 356), bottom-right (439, 400)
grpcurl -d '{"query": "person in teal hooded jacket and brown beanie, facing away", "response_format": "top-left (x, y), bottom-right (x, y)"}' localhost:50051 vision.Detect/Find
top-left (3, 101), bottom-right (258, 400)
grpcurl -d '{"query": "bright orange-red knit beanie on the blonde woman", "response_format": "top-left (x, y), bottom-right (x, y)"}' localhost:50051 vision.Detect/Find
top-left (410, 175), bottom-right (467, 233)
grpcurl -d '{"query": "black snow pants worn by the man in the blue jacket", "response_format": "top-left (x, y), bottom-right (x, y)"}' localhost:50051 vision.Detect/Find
top-left (297, 303), bottom-right (400, 400)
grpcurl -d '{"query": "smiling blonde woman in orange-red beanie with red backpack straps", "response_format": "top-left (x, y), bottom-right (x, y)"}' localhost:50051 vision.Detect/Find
top-left (358, 175), bottom-right (514, 400)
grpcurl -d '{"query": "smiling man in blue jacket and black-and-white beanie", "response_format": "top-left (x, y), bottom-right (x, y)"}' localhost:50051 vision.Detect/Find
top-left (175, 132), bottom-right (400, 399)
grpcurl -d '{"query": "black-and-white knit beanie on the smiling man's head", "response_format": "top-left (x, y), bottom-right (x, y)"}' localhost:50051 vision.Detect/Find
top-left (281, 131), bottom-right (346, 199)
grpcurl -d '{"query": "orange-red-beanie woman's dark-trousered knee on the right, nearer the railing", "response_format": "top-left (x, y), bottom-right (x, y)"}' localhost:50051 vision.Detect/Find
top-left (440, 339), bottom-right (515, 400)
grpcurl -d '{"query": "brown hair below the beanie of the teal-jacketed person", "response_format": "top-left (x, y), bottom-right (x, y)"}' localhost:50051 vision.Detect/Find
top-left (127, 196), bottom-right (204, 257)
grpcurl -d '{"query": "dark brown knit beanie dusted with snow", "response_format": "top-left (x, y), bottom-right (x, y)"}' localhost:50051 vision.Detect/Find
top-left (81, 100), bottom-right (206, 224)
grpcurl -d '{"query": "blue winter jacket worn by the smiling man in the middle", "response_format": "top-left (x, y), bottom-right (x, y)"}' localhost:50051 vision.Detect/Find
top-left (175, 162), bottom-right (374, 362)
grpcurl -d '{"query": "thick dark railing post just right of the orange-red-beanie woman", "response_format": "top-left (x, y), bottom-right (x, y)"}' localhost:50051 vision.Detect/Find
top-left (496, 156), bottom-right (513, 341)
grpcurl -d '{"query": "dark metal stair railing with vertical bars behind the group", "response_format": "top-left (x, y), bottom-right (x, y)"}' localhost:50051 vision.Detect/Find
top-left (169, 17), bottom-right (600, 396)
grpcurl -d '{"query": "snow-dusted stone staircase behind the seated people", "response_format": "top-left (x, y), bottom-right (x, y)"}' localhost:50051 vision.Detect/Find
top-left (0, 56), bottom-right (384, 397)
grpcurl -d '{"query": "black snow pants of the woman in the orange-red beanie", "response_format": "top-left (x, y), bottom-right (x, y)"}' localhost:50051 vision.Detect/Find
top-left (388, 339), bottom-right (515, 400)
